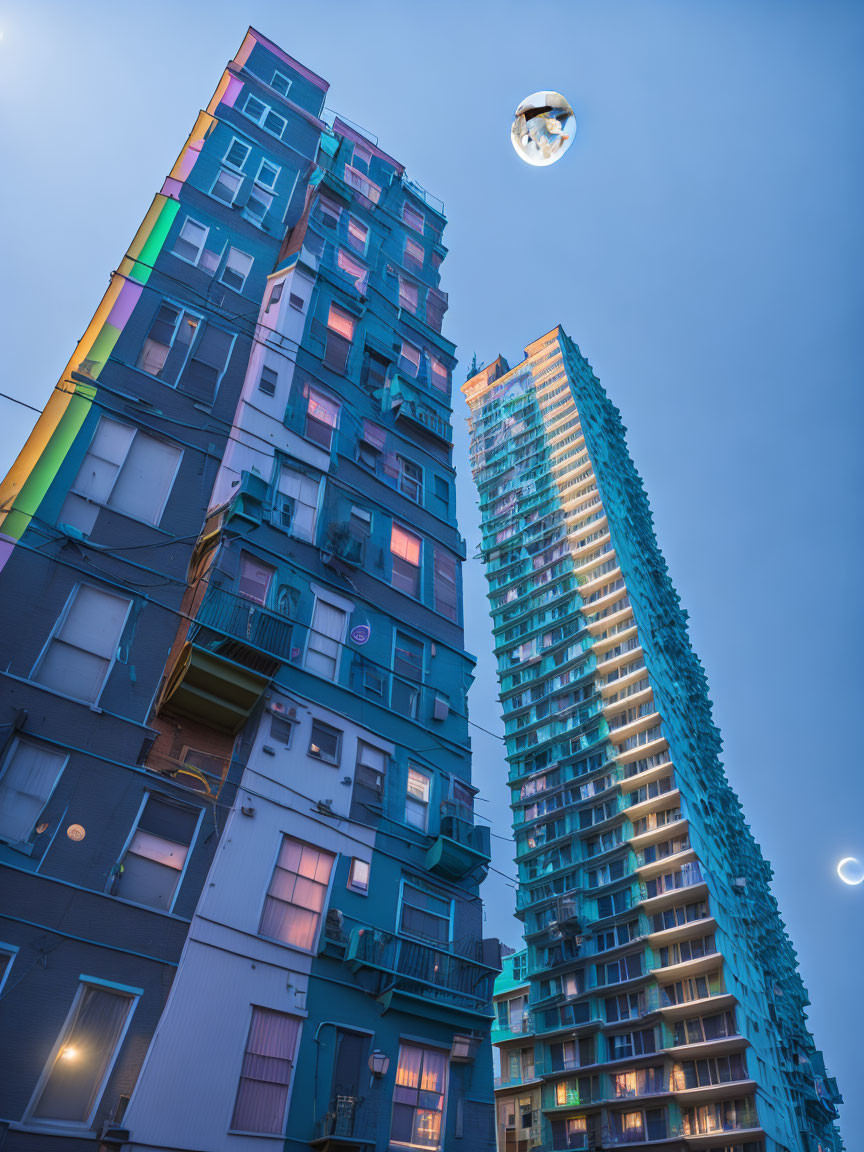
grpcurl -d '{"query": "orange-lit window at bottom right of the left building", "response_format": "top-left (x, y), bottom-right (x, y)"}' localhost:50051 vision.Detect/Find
top-left (391, 1044), bottom-right (447, 1149)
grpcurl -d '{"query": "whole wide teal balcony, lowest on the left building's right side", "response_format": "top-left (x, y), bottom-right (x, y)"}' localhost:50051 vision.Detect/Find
top-left (344, 927), bottom-right (498, 1026)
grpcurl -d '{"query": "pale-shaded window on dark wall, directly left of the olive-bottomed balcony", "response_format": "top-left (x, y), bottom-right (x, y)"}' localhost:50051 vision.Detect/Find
top-left (32, 584), bottom-right (131, 703)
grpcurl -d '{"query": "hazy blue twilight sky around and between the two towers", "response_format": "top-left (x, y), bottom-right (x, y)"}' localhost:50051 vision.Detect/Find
top-left (0, 0), bottom-right (864, 1133)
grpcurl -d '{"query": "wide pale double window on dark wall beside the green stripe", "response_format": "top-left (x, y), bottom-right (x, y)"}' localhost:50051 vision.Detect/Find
top-left (60, 416), bottom-right (183, 533)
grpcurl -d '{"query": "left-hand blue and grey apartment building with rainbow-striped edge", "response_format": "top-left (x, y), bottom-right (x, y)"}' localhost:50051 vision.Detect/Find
top-left (0, 30), bottom-right (500, 1152)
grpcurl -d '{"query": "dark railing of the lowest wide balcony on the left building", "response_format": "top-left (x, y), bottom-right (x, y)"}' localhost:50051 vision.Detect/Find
top-left (346, 927), bottom-right (498, 1015)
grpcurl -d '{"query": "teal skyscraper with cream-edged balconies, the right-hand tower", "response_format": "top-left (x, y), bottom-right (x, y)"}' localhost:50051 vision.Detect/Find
top-left (463, 327), bottom-right (842, 1152)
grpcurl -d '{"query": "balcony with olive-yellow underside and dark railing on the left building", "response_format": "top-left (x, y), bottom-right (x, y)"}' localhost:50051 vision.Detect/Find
top-left (159, 588), bottom-right (291, 734)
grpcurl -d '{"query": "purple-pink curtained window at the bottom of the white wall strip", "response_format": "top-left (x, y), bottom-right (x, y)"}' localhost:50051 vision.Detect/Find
top-left (232, 1007), bottom-right (301, 1136)
